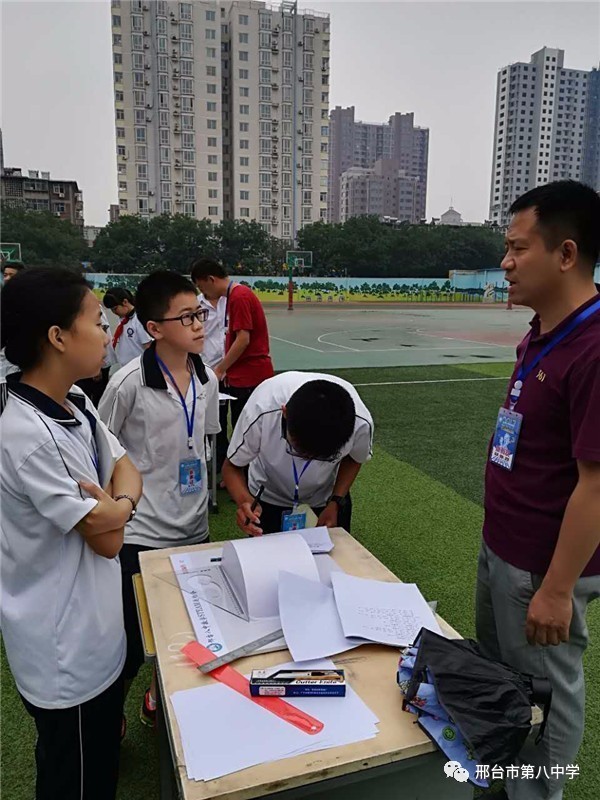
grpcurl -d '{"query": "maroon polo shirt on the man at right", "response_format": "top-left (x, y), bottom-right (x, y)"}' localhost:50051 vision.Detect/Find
top-left (483, 294), bottom-right (600, 575)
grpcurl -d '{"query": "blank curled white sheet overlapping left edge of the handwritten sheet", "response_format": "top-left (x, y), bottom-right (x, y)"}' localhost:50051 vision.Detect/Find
top-left (279, 572), bottom-right (365, 661)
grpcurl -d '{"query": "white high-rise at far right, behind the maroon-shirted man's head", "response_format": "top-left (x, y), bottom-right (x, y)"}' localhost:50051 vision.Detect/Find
top-left (490, 47), bottom-right (598, 225)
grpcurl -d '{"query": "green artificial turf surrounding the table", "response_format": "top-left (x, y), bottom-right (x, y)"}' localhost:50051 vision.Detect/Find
top-left (1, 363), bottom-right (600, 800)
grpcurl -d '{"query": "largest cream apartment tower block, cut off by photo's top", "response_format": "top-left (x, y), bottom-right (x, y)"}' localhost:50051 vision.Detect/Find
top-left (112, 0), bottom-right (329, 240)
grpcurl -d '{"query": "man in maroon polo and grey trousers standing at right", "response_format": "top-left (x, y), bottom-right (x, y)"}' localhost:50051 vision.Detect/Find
top-left (476, 181), bottom-right (600, 800)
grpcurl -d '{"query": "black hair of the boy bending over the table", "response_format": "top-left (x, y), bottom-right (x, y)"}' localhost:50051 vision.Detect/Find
top-left (285, 380), bottom-right (356, 460)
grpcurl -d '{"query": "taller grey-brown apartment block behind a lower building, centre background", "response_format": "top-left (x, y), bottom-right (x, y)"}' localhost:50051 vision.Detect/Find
top-left (327, 106), bottom-right (429, 222)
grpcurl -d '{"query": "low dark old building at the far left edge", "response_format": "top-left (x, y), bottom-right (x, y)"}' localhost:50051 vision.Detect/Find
top-left (0, 167), bottom-right (83, 227)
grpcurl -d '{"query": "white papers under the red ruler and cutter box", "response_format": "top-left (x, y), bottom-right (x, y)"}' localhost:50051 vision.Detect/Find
top-left (171, 659), bottom-right (379, 781)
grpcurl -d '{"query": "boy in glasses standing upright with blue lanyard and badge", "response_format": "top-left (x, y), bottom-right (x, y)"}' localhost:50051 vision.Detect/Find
top-left (99, 271), bottom-right (220, 725)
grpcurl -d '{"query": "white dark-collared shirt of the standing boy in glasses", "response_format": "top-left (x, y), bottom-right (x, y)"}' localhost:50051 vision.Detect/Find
top-left (98, 344), bottom-right (221, 547)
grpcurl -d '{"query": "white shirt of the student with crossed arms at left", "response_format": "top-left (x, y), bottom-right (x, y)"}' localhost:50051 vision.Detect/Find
top-left (0, 381), bottom-right (126, 709)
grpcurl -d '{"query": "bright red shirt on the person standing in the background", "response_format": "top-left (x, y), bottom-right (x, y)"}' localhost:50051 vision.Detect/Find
top-left (225, 284), bottom-right (274, 388)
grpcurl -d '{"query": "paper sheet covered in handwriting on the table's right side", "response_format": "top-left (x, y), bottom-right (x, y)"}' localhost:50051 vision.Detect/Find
top-left (331, 573), bottom-right (443, 647)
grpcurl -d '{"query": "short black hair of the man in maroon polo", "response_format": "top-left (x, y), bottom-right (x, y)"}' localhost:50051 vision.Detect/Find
top-left (510, 181), bottom-right (600, 269)
